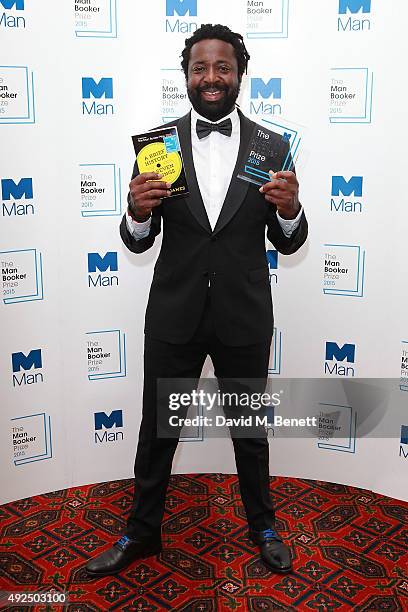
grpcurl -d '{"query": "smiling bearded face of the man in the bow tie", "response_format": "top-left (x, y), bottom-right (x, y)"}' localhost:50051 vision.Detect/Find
top-left (187, 38), bottom-right (240, 121)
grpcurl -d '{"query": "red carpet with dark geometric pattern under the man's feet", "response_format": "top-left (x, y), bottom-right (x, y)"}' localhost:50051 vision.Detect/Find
top-left (0, 474), bottom-right (408, 612)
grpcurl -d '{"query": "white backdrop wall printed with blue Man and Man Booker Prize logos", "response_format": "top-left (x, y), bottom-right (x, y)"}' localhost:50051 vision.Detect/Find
top-left (0, 0), bottom-right (408, 502)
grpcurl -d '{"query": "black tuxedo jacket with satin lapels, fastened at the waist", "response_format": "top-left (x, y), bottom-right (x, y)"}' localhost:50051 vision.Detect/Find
top-left (120, 112), bottom-right (307, 346)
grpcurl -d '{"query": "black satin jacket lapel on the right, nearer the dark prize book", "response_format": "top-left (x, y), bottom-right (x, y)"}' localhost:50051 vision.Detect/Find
top-left (214, 111), bottom-right (254, 234)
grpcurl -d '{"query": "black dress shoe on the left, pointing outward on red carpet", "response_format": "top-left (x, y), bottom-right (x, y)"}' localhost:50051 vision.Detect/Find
top-left (85, 534), bottom-right (162, 576)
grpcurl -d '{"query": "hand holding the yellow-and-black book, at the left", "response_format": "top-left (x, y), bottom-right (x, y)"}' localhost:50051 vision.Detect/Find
top-left (129, 172), bottom-right (171, 219)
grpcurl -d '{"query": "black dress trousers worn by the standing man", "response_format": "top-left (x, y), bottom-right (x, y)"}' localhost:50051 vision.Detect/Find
top-left (126, 289), bottom-right (275, 537)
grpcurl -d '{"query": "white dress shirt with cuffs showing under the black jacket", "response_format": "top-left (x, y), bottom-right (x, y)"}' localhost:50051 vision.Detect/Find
top-left (126, 109), bottom-right (302, 240)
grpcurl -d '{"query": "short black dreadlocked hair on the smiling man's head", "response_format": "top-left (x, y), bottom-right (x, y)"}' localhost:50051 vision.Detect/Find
top-left (181, 23), bottom-right (250, 80)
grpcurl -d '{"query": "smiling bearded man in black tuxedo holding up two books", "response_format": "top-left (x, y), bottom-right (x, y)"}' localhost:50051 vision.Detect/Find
top-left (87, 24), bottom-right (307, 576)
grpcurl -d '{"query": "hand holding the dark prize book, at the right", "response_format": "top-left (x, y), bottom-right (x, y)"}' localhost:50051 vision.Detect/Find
top-left (259, 170), bottom-right (300, 219)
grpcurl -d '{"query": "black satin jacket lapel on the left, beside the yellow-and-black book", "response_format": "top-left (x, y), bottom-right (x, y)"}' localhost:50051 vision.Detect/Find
top-left (177, 113), bottom-right (212, 233)
